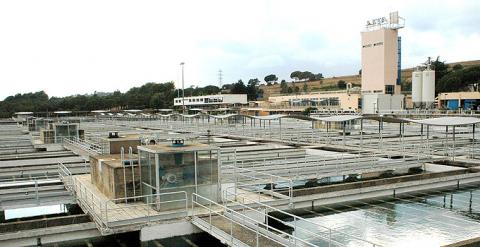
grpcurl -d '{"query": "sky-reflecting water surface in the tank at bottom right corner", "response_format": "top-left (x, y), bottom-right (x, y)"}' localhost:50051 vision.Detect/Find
top-left (290, 187), bottom-right (480, 247)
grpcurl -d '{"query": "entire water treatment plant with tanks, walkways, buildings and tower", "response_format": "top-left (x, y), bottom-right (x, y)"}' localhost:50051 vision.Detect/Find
top-left (0, 5), bottom-right (480, 247)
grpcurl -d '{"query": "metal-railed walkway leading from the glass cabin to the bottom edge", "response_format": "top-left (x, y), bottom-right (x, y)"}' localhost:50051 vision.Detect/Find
top-left (191, 193), bottom-right (380, 247)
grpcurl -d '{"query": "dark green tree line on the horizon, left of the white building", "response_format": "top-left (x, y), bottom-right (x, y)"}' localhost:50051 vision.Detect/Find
top-left (0, 82), bottom-right (220, 117)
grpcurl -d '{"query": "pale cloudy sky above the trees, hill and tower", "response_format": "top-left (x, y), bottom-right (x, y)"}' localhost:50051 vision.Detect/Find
top-left (0, 0), bottom-right (480, 99)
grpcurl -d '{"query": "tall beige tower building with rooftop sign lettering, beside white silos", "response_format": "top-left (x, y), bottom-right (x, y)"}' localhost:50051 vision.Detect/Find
top-left (361, 12), bottom-right (405, 114)
